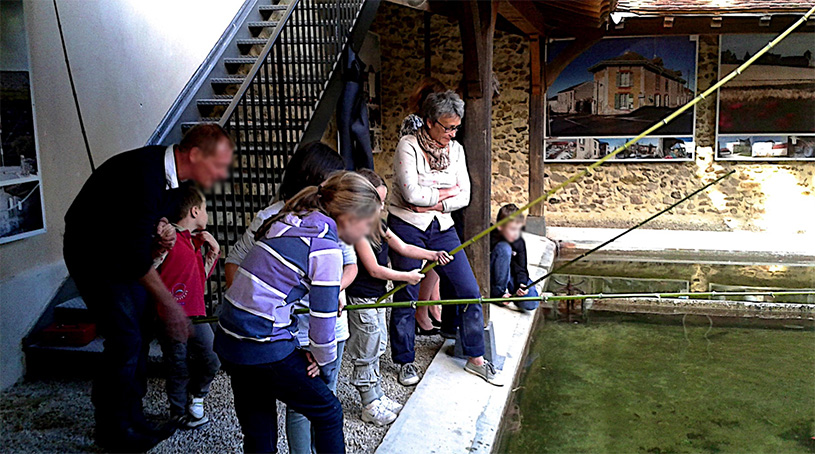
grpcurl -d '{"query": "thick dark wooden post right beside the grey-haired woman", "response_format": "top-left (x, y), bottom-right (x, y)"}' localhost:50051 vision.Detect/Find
top-left (459, 0), bottom-right (498, 310)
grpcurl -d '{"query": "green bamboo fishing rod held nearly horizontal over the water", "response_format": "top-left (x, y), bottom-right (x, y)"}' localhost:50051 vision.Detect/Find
top-left (193, 290), bottom-right (815, 324)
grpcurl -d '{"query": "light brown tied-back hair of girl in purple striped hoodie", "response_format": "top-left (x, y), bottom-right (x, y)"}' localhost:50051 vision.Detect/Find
top-left (255, 171), bottom-right (382, 240)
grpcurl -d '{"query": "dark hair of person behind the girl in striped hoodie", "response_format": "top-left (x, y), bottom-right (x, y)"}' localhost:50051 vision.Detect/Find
top-left (278, 142), bottom-right (345, 200)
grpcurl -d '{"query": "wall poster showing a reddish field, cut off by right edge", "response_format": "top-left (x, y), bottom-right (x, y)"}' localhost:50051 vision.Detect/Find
top-left (716, 33), bottom-right (815, 160)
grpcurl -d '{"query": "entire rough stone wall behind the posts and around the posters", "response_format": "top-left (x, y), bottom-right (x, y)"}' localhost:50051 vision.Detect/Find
top-left (372, 2), bottom-right (815, 233)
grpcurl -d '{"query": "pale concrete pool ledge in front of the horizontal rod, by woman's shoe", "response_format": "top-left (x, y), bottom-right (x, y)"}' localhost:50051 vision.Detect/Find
top-left (376, 307), bottom-right (535, 454)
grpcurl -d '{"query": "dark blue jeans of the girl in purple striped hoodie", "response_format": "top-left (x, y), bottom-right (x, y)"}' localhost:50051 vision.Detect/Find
top-left (224, 349), bottom-right (345, 453)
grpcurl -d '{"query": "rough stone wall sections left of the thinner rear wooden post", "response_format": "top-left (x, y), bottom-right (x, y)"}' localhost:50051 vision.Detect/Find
top-left (371, 2), bottom-right (529, 220)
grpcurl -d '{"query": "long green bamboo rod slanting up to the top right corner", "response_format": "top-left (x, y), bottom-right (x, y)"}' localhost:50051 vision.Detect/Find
top-left (376, 6), bottom-right (815, 303)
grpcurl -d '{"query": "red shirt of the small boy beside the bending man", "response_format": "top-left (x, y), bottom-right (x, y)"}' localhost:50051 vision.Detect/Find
top-left (158, 230), bottom-right (215, 317)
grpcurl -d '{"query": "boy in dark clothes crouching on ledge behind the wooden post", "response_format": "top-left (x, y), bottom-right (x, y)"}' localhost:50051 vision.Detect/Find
top-left (490, 203), bottom-right (538, 311)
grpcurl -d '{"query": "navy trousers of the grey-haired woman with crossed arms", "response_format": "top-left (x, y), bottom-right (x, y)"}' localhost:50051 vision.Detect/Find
top-left (388, 215), bottom-right (484, 364)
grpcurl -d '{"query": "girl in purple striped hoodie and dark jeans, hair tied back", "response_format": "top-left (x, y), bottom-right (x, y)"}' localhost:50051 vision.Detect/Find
top-left (215, 172), bottom-right (382, 453)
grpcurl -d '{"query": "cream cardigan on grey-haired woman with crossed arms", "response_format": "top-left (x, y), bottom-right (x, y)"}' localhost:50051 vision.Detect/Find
top-left (390, 135), bottom-right (470, 231)
